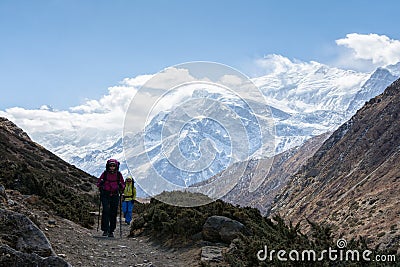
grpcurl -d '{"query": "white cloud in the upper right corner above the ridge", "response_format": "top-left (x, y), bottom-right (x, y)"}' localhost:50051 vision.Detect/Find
top-left (336, 33), bottom-right (400, 70)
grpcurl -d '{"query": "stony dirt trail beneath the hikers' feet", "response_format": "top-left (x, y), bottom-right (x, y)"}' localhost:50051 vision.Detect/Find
top-left (40, 218), bottom-right (201, 267)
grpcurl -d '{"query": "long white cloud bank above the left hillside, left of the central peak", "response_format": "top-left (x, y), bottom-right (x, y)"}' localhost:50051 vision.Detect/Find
top-left (0, 75), bottom-right (151, 147)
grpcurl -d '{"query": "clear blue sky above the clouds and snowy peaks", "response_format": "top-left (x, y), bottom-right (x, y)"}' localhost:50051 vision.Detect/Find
top-left (0, 0), bottom-right (400, 110)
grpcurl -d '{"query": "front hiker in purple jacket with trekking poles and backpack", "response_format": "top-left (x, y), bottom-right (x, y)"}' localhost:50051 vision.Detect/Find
top-left (97, 159), bottom-right (125, 237)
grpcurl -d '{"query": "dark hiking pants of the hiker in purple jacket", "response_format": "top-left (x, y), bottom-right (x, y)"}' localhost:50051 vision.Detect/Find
top-left (100, 191), bottom-right (119, 233)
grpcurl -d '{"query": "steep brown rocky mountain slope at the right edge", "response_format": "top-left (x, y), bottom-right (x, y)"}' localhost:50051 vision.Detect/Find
top-left (271, 80), bottom-right (400, 251)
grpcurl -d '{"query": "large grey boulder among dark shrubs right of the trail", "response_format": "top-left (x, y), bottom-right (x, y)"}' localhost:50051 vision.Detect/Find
top-left (202, 216), bottom-right (246, 244)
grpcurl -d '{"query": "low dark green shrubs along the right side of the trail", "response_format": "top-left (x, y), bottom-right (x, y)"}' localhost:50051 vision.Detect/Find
top-left (130, 192), bottom-right (396, 266)
